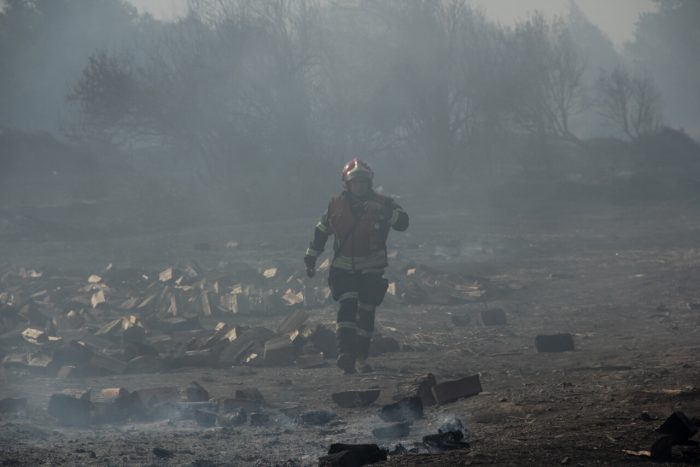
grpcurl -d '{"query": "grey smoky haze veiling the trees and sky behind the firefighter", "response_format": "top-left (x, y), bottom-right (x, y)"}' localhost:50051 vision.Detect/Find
top-left (0, 0), bottom-right (700, 230)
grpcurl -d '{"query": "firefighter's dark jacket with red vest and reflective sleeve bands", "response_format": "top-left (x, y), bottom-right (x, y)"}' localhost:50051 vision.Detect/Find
top-left (306, 191), bottom-right (408, 272)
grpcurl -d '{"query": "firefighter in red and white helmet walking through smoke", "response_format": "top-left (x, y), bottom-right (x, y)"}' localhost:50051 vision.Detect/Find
top-left (304, 158), bottom-right (408, 374)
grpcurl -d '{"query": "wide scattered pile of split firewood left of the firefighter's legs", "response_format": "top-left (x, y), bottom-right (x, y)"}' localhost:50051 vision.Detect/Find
top-left (0, 262), bottom-right (388, 378)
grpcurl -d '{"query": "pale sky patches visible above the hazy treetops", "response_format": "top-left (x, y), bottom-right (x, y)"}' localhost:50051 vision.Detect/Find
top-left (129, 0), bottom-right (655, 48)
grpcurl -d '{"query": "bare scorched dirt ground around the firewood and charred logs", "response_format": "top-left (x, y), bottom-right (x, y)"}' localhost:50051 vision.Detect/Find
top-left (0, 203), bottom-right (700, 466)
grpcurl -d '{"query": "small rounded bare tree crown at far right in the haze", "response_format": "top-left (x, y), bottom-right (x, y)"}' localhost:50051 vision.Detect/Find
top-left (598, 65), bottom-right (662, 140)
